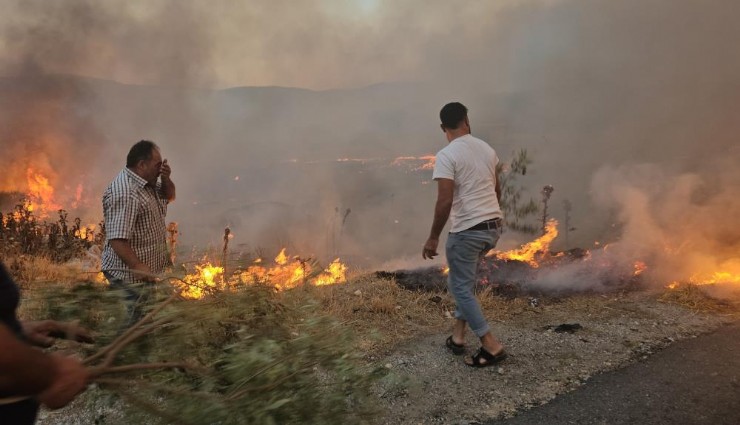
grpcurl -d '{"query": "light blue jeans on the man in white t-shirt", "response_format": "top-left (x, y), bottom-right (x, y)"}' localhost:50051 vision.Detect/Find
top-left (445, 228), bottom-right (501, 338)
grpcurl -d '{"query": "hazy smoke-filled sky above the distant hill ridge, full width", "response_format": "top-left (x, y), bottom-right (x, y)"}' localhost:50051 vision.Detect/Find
top-left (0, 0), bottom-right (739, 90)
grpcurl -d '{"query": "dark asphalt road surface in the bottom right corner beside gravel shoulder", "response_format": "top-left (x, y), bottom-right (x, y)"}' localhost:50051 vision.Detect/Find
top-left (485, 323), bottom-right (740, 425)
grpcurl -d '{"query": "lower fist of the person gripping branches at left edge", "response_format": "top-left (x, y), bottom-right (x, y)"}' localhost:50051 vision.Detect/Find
top-left (38, 354), bottom-right (90, 409)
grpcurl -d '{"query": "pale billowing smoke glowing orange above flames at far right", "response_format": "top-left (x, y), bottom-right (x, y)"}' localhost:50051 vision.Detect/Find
top-left (530, 147), bottom-right (740, 291)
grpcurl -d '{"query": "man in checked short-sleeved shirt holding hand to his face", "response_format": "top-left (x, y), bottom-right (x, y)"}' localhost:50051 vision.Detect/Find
top-left (102, 140), bottom-right (175, 325)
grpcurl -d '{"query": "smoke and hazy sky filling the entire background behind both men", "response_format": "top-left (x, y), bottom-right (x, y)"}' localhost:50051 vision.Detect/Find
top-left (0, 0), bottom-right (740, 284)
